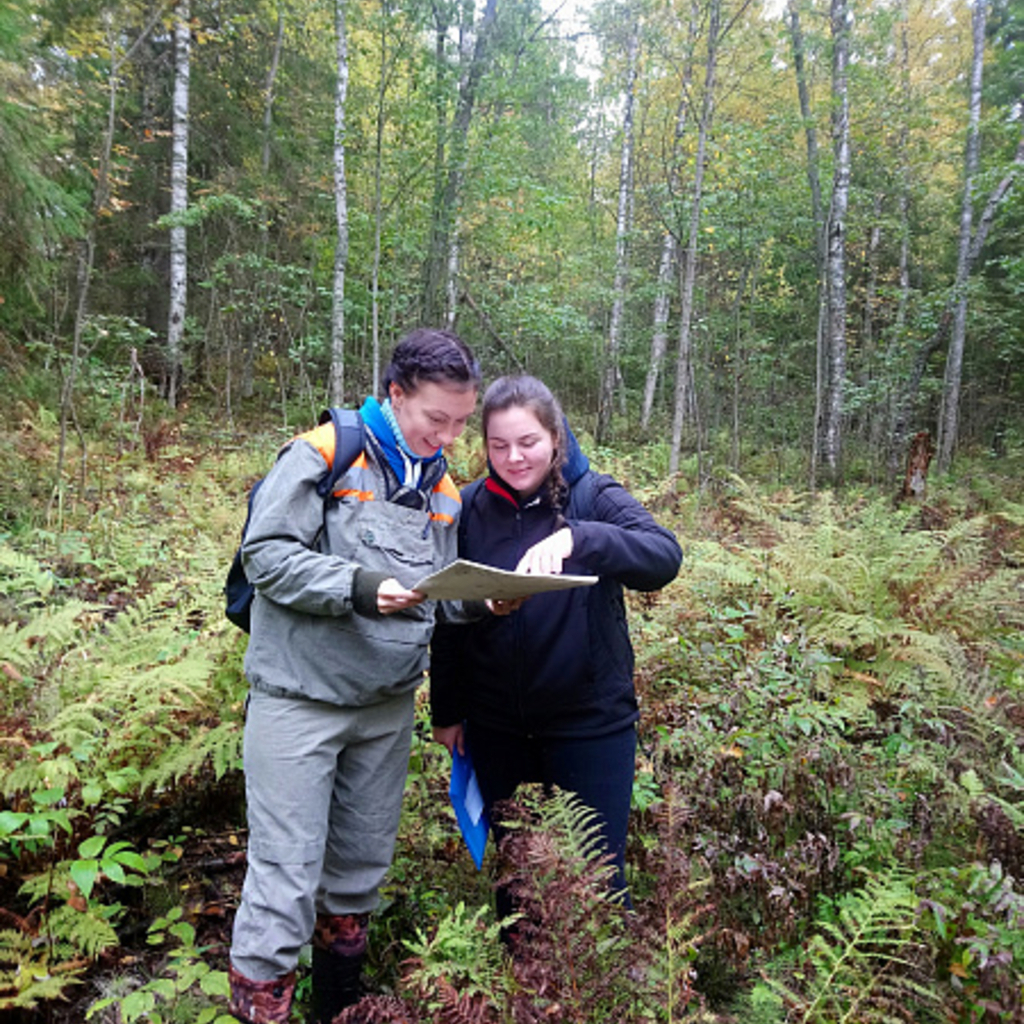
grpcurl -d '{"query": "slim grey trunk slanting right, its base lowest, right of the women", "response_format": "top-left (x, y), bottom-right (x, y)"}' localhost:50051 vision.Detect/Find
top-left (669, 0), bottom-right (722, 473)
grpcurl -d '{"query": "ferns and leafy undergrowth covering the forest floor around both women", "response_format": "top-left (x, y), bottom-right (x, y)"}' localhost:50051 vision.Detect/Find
top-left (0, 399), bottom-right (1024, 1024)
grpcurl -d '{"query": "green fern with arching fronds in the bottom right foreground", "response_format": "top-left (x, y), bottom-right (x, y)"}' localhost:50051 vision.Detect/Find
top-left (767, 870), bottom-right (936, 1024)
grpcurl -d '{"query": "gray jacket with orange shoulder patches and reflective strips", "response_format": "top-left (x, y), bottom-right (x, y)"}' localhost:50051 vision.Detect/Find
top-left (242, 424), bottom-right (466, 707)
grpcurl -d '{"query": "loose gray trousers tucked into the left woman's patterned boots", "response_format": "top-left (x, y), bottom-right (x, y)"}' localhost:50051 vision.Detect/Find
top-left (231, 690), bottom-right (415, 981)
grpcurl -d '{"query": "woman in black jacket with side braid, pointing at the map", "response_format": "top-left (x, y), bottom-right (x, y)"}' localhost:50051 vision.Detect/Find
top-left (430, 377), bottom-right (682, 912)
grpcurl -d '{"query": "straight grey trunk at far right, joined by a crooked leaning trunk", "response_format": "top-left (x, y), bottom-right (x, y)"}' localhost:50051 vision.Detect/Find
top-left (937, 0), bottom-right (988, 472)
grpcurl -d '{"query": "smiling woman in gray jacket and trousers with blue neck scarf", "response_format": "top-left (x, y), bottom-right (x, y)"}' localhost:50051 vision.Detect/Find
top-left (230, 329), bottom-right (480, 1024)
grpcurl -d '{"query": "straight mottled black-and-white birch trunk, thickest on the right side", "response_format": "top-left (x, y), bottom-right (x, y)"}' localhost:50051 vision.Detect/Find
top-left (821, 0), bottom-right (850, 483)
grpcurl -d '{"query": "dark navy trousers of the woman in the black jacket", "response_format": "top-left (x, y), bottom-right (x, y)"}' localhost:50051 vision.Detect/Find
top-left (466, 723), bottom-right (637, 910)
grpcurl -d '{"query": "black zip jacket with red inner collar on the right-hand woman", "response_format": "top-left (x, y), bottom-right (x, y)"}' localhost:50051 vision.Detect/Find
top-left (430, 434), bottom-right (682, 737)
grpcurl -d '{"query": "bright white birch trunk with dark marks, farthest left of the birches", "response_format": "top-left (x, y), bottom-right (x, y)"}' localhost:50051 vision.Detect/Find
top-left (167, 0), bottom-right (191, 409)
